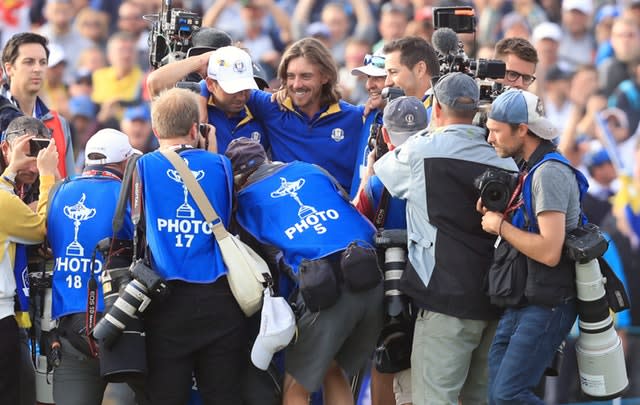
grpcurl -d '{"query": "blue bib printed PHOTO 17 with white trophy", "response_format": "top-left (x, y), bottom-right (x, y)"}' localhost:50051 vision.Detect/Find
top-left (138, 149), bottom-right (232, 283)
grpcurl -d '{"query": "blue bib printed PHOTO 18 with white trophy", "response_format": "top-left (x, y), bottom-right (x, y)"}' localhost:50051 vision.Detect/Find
top-left (47, 176), bottom-right (133, 319)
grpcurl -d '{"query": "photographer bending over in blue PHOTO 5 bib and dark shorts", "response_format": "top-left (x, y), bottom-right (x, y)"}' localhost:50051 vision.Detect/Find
top-left (226, 138), bottom-right (383, 405)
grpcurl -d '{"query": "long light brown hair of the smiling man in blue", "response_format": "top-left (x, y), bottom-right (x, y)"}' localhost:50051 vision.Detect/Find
top-left (278, 38), bottom-right (341, 105)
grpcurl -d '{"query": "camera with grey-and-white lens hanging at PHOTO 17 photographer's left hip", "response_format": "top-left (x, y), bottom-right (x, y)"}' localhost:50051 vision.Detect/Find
top-left (93, 259), bottom-right (168, 347)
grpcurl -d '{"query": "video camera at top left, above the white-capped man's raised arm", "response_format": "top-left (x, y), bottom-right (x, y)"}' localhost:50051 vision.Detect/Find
top-left (143, 0), bottom-right (202, 69)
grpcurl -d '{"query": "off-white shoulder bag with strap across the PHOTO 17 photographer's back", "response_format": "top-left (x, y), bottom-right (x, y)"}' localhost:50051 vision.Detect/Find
top-left (162, 150), bottom-right (273, 316)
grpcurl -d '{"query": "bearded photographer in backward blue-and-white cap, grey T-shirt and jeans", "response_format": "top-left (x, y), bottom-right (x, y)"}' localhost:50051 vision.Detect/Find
top-left (477, 90), bottom-right (587, 404)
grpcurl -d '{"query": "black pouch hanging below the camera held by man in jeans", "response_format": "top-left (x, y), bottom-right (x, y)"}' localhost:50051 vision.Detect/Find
top-left (486, 239), bottom-right (527, 307)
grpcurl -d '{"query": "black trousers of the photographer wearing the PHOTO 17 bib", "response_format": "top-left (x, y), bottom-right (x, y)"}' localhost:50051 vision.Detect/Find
top-left (145, 277), bottom-right (249, 405)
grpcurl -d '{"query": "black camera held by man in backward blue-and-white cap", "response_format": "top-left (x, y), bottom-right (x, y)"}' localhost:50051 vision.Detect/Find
top-left (473, 168), bottom-right (518, 212)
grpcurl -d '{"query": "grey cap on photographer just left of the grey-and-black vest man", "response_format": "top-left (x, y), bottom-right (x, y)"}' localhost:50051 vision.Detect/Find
top-left (382, 96), bottom-right (427, 146)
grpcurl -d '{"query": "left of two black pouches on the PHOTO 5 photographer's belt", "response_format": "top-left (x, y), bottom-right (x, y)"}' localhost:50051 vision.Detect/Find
top-left (298, 258), bottom-right (340, 312)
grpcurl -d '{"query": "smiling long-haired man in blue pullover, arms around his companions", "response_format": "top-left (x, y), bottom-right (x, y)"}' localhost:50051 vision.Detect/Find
top-left (247, 38), bottom-right (364, 190)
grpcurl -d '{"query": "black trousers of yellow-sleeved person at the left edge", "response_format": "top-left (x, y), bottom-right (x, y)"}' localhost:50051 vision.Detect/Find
top-left (0, 315), bottom-right (20, 404)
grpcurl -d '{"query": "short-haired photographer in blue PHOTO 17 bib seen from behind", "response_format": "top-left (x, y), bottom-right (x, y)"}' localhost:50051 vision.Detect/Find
top-left (135, 88), bottom-right (248, 405)
